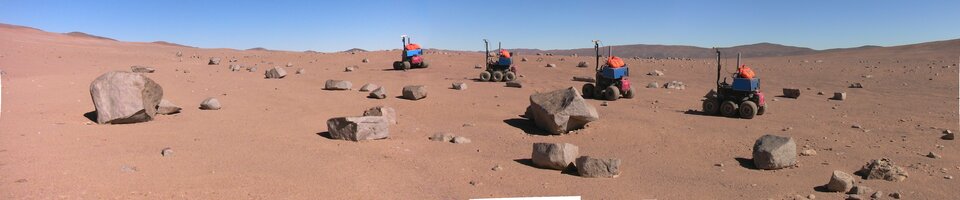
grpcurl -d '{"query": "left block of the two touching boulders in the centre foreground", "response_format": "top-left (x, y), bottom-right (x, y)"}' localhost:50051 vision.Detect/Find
top-left (530, 143), bottom-right (580, 170)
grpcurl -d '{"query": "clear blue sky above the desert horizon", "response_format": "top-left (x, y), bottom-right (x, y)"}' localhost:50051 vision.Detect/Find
top-left (0, 0), bottom-right (960, 52)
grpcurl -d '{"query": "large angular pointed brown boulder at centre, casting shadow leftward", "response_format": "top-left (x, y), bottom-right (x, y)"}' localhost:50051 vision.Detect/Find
top-left (525, 87), bottom-right (600, 135)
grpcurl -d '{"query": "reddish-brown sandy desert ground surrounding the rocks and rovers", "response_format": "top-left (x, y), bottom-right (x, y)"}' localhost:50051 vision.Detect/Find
top-left (0, 23), bottom-right (960, 199)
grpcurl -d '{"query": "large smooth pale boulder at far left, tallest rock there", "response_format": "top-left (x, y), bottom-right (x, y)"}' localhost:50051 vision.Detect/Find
top-left (90, 71), bottom-right (163, 124)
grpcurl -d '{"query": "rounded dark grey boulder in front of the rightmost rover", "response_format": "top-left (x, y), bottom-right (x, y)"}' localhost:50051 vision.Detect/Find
top-left (753, 135), bottom-right (797, 170)
